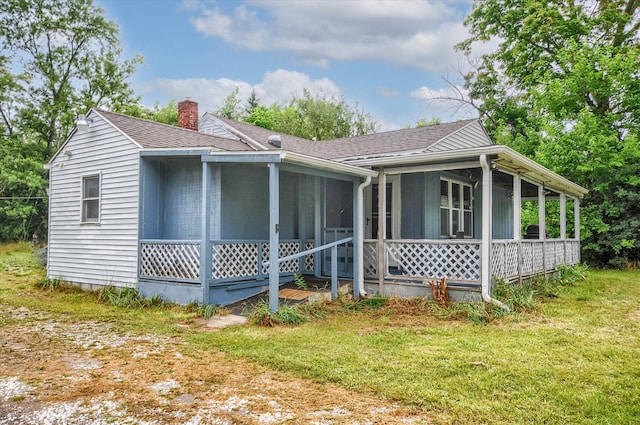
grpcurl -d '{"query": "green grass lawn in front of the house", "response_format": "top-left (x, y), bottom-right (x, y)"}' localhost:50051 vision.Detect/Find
top-left (0, 248), bottom-right (640, 425)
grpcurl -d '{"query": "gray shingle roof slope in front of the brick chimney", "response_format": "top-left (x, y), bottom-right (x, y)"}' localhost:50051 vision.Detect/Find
top-left (94, 109), bottom-right (253, 151)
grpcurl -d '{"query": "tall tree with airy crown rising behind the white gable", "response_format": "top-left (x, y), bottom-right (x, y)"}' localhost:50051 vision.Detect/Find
top-left (0, 0), bottom-right (141, 152)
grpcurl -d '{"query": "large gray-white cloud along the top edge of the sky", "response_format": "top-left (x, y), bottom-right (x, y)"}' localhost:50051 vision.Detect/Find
top-left (185, 0), bottom-right (468, 72)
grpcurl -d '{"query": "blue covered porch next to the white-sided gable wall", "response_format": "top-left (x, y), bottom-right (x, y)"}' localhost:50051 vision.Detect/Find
top-left (138, 150), bottom-right (376, 309)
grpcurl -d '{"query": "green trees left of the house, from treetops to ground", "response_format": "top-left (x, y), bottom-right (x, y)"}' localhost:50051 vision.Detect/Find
top-left (0, 0), bottom-right (141, 240)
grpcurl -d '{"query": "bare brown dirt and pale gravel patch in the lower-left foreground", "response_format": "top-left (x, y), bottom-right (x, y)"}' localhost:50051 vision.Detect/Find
top-left (0, 305), bottom-right (429, 425)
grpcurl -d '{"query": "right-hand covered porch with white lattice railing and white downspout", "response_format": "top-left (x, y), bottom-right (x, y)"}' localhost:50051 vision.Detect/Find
top-left (350, 146), bottom-right (586, 300)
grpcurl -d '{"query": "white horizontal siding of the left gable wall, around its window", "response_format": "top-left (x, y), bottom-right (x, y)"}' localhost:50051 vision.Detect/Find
top-left (48, 113), bottom-right (139, 286)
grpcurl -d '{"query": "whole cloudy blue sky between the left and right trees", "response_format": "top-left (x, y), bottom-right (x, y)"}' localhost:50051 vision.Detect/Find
top-left (97, 0), bottom-right (482, 130)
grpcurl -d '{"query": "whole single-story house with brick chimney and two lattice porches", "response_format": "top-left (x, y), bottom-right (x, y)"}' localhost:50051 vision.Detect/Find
top-left (48, 100), bottom-right (587, 310)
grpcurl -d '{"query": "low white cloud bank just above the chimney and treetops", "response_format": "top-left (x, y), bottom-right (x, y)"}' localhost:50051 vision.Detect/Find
top-left (135, 69), bottom-right (342, 113)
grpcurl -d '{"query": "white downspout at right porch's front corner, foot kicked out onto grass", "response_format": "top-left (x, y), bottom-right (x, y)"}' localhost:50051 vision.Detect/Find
top-left (480, 154), bottom-right (510, 311)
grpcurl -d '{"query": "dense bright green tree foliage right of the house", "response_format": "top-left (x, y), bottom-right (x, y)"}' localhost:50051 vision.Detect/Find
top-left (459, 0), bottom-right (640, 265)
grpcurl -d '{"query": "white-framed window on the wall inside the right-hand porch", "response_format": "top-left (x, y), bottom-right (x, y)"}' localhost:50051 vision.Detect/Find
top-left (440, 179), bottom-right (473, 238)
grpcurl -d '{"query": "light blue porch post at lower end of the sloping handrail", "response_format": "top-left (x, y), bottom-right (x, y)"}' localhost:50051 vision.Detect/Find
top-left (269, 162), bottom-right (280, 313)
